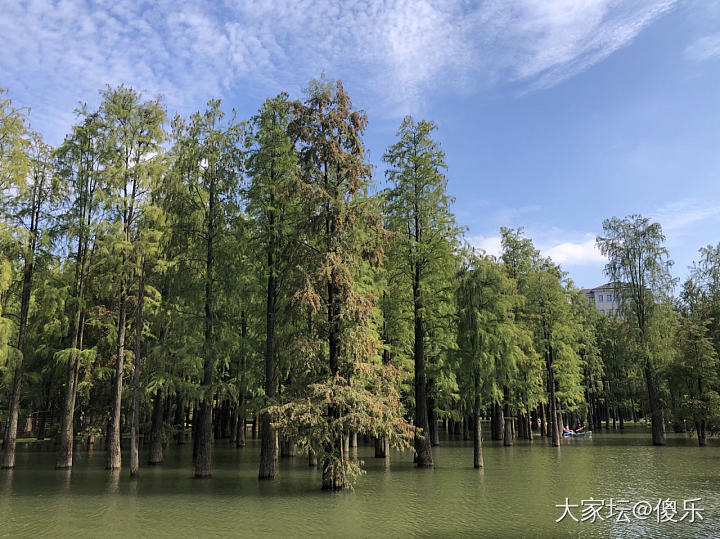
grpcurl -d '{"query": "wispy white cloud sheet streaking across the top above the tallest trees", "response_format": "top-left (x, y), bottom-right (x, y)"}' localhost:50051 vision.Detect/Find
top-left (0, 0), bottom-right (676, 139)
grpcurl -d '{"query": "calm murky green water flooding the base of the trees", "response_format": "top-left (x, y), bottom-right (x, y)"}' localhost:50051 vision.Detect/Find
top-left (0, 430), bottom-right (720, 537)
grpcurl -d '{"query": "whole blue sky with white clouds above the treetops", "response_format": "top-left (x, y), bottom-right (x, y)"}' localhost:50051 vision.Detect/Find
top-left (0, 0), bottom-right (720, 292)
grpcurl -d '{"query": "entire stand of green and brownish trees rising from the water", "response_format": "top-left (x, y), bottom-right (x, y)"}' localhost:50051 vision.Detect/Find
top-left (0, 83), bottom-right (720, 490)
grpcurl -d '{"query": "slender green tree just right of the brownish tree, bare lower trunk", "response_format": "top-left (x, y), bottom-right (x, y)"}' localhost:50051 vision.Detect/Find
top-left (383, 116), bottom-right (458, 468)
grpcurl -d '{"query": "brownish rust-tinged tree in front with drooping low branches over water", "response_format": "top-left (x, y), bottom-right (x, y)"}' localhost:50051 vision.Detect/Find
top-left (279, 80), bottom-right (409, 490)
